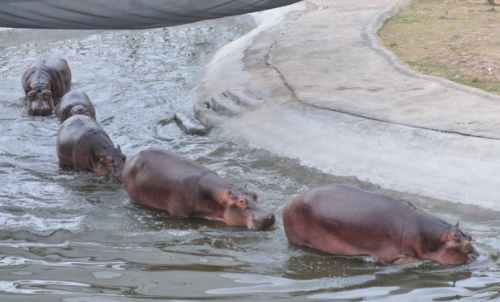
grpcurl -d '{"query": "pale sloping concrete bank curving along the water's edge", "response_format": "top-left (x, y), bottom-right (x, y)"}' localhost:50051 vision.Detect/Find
top-left (194, 0), bottom-right (500, 211)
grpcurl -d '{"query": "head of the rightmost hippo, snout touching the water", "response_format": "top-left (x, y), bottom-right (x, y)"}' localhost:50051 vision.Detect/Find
top-left (430, 224), bottom-right (479, 264)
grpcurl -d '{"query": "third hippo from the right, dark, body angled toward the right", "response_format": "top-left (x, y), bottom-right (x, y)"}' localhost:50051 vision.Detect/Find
top-left (57, 115), bottom-right (127, 183)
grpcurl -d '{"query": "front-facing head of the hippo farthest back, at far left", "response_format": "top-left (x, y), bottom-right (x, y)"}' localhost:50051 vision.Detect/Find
top-left (26, 83), bottom-right (54, 116)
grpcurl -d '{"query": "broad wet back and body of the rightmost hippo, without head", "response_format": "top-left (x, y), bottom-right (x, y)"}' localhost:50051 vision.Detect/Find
top-left (283, 185), bottom-right (417, 262)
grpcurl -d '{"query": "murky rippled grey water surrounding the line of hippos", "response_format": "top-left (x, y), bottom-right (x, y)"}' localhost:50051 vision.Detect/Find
top-left (0, 17), bottom-right (500, 302)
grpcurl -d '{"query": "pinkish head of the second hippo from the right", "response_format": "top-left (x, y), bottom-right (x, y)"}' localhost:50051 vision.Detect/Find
top-left (216, 187), bottom-right (275, 230)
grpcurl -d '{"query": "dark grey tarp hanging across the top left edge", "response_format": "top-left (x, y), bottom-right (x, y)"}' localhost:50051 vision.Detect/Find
top-left (0, 0), bottom-right (298, 29)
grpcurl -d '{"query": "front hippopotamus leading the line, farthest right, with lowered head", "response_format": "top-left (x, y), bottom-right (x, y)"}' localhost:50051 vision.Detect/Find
top-left (283, 185), bottom-right (479, 264)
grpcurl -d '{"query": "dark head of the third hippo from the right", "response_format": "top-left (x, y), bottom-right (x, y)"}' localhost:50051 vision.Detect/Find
top-left (97, 146), bottom-right (127, 183)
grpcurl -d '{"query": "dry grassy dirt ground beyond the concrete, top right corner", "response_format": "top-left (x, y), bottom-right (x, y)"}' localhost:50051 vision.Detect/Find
top-left (379, 0), bottom-right (500, 94)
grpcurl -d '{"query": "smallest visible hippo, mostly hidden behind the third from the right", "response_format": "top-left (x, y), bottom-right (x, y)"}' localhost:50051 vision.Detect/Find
top-left (56, 90), bottom-right (95, 123)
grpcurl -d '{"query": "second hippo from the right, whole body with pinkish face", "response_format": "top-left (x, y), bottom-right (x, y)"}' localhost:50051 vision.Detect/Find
top-left (123, 149), bottom-right (275, 230)
